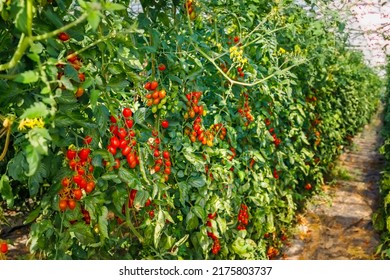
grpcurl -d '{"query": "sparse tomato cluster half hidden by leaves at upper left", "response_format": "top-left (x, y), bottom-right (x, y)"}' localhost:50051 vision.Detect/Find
top-left (57, 32), bottom-right (85, 98)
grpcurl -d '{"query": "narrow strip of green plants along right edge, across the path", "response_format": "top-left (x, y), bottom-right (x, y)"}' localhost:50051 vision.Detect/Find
top-left (373, 58), bottom-right (390, 259)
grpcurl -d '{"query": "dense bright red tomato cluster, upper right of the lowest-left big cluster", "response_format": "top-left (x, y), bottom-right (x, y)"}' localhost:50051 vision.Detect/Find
top-left (106, 107), bottom-right (139, 169)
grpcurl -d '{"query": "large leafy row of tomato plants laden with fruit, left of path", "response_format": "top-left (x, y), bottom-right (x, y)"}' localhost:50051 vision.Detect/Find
top-left (0, 0), bottom-right (381, 259)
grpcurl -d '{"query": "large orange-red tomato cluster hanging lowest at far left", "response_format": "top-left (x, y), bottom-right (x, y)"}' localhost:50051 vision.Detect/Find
top-left (59, 141), bottom-right (95, 211)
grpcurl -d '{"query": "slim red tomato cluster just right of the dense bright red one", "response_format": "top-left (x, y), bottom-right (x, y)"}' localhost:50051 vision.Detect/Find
top-left (149, 131), bottom-right (172, 182)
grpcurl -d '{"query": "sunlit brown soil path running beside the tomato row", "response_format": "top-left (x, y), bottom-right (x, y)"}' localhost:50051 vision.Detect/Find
top-left (284, 108), bottom-right (384, 260)
